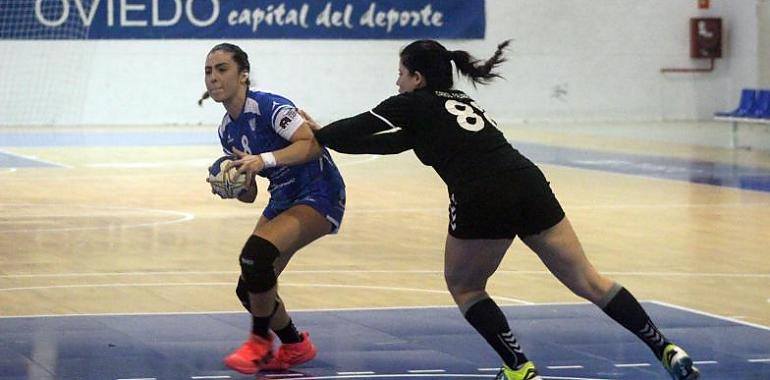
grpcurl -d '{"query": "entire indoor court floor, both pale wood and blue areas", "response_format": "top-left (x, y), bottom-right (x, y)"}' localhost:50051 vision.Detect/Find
top-left (0, 123), bottom-right (770, 380)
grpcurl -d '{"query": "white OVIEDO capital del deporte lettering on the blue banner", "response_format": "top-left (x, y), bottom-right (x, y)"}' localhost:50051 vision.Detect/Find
top-left (35, 0), bottom-right (444, 32)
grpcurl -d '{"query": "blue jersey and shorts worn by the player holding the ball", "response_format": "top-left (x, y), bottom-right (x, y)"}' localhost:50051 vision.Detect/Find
top-left (219, 90), bottom-right (345, 232)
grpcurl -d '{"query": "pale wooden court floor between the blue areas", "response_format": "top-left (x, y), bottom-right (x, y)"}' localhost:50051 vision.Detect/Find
top-left (0, 122), bottom-right (770, 326)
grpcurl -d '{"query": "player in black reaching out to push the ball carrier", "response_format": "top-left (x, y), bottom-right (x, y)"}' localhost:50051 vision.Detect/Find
top-left (307, 40), bottom-right (699, 380)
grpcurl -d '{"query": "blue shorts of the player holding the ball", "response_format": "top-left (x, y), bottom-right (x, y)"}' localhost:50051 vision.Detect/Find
top-left (262, 174), bottom-right (345, 234)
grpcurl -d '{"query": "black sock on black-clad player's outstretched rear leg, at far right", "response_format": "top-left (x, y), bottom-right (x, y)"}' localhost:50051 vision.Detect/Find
top-left (602, 288), bottom-right (670, 360)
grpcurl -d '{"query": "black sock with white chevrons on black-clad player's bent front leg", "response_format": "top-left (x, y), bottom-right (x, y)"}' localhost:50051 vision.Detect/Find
top-left (465, 298), bottom-right (527, 369)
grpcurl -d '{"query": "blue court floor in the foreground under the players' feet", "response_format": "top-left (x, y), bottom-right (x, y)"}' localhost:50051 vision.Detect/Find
top-left (0, 302), bottom-right (770, 380)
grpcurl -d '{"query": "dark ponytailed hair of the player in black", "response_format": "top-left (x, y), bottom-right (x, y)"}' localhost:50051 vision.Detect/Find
top-left (400, 40), bottom-right (511, 90)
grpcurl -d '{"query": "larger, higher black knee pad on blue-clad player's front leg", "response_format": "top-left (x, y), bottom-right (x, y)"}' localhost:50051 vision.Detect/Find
top-left (239, 235), bottom-right (280, 293)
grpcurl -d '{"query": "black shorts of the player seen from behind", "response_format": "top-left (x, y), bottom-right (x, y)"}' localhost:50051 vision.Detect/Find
top-left (449, 167), bottom-right (564, 239)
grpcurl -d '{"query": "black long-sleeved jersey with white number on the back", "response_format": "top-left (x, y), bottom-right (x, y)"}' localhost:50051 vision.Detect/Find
top-left (316, 89), bottom-right (534, 188)
